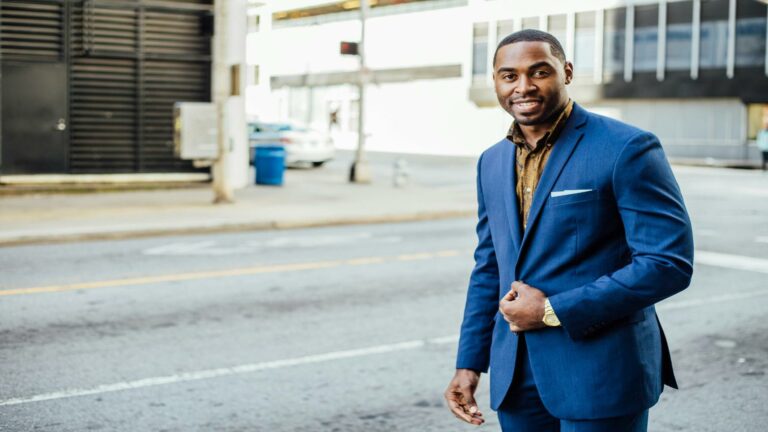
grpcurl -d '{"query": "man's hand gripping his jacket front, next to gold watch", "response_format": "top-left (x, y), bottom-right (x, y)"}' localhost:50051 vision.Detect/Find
top-left (499, 281), bottom-right (547, 332)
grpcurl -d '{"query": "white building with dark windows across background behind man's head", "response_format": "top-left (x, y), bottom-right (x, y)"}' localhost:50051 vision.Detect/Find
top-left (247, 0), bottom-right (768, 162)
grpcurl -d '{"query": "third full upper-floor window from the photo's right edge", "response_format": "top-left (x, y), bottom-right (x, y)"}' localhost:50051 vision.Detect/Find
top-left (666, 1), bottom-right (693, 71)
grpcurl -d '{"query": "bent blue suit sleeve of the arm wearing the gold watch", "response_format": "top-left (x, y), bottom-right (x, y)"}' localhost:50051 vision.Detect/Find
top-left (550, 133), bottom-right (693, 339)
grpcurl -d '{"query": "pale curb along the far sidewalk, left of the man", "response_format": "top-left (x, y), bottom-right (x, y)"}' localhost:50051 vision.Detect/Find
top-left (0, 210), bottom-right (477, 247)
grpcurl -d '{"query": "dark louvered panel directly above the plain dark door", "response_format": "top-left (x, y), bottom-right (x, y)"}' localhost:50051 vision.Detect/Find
top-left (0, 0), bottom-right (64, 61)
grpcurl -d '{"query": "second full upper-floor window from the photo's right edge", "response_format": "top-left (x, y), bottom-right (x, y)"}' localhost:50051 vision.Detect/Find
top-left (699, 0), bottom-right (728, 69)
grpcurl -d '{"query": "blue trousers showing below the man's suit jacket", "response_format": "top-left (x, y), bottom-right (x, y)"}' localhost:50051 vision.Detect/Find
top-left (497, 334), bottom-right (648, 432)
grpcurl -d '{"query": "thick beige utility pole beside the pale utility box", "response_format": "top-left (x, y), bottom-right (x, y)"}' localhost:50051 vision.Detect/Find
top-left (211, 0), bottom-right (235, 204)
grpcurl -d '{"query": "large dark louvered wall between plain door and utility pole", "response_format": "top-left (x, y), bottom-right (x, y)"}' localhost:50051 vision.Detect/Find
top-left (64, 0), bottom-right (212, 172)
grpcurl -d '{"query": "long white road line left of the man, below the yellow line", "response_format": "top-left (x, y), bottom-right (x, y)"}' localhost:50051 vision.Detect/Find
top-left (0, 336), bottom-right (458, 407)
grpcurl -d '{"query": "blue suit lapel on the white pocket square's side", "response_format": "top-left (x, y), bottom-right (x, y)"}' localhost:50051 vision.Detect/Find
top-left (513, 104), bottom-right (587, 260)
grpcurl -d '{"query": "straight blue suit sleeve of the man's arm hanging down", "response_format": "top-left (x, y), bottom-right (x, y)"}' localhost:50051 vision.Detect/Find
top-left (456, 156), bottom-right (499, 372)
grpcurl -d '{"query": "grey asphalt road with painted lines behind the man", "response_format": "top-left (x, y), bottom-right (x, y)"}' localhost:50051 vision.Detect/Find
top-left (0, 164), bottom-right (768, 432)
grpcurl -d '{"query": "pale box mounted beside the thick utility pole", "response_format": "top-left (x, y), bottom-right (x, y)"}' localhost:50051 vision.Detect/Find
top-left (173, 102), bottom-right (219, 160)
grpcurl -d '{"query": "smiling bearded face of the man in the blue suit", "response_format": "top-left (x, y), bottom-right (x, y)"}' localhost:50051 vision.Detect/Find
top-left (493, 42), bottom-right (573, 127)
